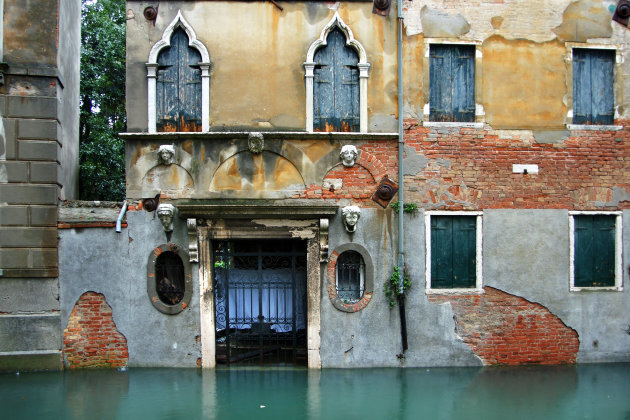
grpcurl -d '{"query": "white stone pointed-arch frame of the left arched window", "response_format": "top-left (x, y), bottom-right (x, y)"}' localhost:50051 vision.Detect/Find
top-left (146, 10), bottom-right (211, 133)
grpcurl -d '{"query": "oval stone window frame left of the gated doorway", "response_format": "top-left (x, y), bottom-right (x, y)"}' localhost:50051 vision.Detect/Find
top-left (147, 243), bottom-right (193, 315)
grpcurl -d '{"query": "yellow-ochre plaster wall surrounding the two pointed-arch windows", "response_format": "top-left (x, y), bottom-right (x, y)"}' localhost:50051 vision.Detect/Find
top-left (127, 1), bottom-right (397, 132)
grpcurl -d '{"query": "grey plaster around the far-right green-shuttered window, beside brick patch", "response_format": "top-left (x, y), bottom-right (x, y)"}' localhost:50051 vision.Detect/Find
top-left (483, 210), bottom-right (630, 362)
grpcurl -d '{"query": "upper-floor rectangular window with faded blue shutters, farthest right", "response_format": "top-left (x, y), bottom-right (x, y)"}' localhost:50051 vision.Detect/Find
top-left (573, 48), bottom-right (615, 125)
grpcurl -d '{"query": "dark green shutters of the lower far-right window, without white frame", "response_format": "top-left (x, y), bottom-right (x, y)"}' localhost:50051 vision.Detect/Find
top-left (573, 215), bottom-right (615, 287)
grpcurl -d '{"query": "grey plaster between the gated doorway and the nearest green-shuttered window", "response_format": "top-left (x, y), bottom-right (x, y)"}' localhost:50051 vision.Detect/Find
top-left (321, 209), bottom-right (481, 367)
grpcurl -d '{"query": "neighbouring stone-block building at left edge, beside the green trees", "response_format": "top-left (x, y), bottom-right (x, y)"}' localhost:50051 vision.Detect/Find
top-left (0, 0), bottom-right (81, 370)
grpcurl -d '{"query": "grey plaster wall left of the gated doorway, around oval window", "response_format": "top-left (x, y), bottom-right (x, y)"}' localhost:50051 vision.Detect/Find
top-left (59, 211), bottom-right (201, 367)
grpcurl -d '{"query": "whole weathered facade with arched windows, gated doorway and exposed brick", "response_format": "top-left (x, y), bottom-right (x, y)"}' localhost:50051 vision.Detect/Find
top-left (59, 0), bottom-right (630, 368)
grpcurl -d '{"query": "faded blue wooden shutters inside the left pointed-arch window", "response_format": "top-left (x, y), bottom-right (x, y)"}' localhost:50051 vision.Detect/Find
top-left (156, 28), bottom-right (201, 131)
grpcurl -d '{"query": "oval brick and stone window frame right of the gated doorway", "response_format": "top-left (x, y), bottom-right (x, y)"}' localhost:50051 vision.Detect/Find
top-left (328, 243), bottom-right (374, 313)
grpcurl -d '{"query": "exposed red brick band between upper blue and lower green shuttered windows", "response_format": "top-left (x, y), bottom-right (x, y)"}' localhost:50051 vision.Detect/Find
top-left (405, 120), bottom-right (630, 210)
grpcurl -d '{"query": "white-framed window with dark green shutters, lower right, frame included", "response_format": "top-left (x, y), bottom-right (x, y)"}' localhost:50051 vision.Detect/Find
top-left (571, 213), bottom-right (621, 290)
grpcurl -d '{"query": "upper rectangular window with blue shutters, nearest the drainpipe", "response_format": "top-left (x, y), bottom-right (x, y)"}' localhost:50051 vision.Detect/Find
top-left (429, 44), bottom-right (475, 122)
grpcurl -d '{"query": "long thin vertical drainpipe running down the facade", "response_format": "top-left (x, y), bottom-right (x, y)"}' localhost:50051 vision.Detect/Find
top-left (396, 0), bottom-right (409, 354)
